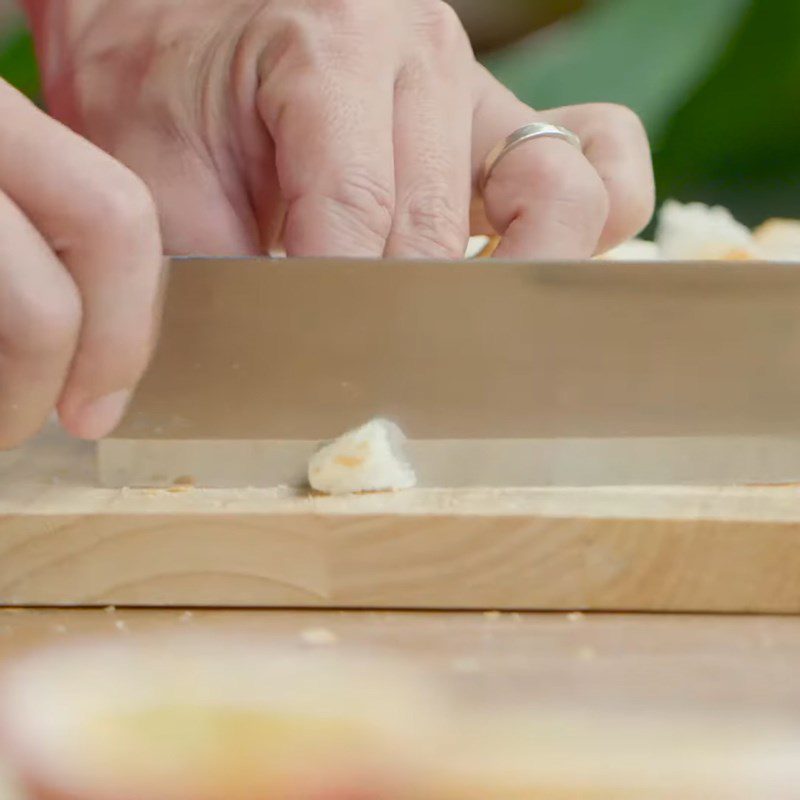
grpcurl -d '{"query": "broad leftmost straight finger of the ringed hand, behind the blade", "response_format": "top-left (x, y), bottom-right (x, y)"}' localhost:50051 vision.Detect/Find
top-left (258, 3), bottom-right (397, 257)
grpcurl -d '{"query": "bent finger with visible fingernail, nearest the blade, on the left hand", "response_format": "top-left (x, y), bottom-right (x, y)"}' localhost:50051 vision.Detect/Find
top-left (0, 82), bottom-right (162, 438)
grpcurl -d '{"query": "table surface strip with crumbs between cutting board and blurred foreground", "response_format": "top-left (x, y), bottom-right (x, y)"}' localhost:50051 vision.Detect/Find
top-left (0, 609), bottom-right (800, 719)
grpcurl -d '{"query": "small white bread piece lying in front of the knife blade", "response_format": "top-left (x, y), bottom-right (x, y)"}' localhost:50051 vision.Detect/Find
top-left (308, 419), bottom-right (417, 495)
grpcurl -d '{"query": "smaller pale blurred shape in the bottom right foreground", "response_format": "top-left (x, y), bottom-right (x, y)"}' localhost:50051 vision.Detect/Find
top-left (428, 709), bottom-right (800, 800)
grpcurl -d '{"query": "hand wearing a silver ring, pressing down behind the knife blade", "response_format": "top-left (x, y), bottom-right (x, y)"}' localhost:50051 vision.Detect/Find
top-left (29, 0), bottom-right (653, 258)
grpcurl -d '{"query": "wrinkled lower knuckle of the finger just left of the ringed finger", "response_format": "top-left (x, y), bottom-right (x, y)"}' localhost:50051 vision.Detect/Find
top-left (401, 190), bottom-right (468, 258)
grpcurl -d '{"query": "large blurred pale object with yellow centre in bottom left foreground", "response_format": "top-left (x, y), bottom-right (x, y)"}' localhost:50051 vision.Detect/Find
top-left (0, 637), bottom-right (433, 800)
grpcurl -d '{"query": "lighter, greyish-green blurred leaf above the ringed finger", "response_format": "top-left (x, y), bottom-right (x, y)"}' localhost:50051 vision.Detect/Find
top-left (485, 0), bottom-right (752, 137)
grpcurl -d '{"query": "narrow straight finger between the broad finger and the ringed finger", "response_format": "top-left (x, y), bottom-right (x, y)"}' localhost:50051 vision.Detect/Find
top-left (386, 4), bottom-right (474, 258)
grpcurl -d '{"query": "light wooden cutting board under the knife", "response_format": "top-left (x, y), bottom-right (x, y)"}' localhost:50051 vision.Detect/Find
top-left (0, 429), bottom-right (800, 613)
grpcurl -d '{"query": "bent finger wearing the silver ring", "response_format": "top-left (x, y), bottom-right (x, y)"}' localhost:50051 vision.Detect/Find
top-left (473, 68), bottom-right (609, 260)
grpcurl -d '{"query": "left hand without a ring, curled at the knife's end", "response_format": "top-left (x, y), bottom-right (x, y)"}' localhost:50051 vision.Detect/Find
top-left (0, 81), bottom-right (161, 448)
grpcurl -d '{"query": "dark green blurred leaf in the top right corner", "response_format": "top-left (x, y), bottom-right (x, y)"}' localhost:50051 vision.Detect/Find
top-left (656, 0), bottom-right (800, 224)
